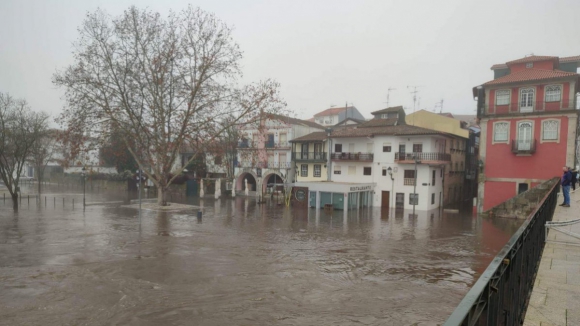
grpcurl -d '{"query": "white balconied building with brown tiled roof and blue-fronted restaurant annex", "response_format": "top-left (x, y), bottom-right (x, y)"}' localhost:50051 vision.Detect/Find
top-left (293, 109), bottom-right (451, 211)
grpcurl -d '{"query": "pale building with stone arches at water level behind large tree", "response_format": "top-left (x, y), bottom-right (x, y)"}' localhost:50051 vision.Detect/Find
top-left (234, 114), bottom-right (324, 196)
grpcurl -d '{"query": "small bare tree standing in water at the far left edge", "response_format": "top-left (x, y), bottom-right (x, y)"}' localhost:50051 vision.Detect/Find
top-left (0, 93), bottom-right (48, 212)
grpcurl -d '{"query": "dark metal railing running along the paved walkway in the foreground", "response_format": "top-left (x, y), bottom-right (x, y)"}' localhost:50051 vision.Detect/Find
top-left (445, 178), bottom-right (559, 326)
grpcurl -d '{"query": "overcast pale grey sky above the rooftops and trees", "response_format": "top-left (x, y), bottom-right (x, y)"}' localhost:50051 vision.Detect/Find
top-left (0, 0), bottom-right (580, 123)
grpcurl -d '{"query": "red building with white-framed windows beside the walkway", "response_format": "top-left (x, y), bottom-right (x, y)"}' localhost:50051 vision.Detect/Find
top-left (473, 55), bottom-right (580, 212)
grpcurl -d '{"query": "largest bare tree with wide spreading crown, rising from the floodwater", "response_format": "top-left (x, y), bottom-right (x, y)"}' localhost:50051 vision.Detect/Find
top-left (53, 6), bottom-right (285, 205)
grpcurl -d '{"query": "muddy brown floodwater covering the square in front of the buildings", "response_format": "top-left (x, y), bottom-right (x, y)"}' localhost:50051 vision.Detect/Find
top-left (0, 188), bottom-right (519, 325)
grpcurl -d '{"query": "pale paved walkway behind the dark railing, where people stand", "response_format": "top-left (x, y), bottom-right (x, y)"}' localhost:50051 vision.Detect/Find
top-left (524, 189), bottom-right (580, 326)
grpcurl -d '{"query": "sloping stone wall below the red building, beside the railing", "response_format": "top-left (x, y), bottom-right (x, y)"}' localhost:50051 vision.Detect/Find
top-left (483, 177), bottom-right (560, 219)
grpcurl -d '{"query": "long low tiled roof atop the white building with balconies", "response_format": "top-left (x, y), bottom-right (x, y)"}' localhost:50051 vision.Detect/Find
top-left (330, 125), bottom-right (448, 138)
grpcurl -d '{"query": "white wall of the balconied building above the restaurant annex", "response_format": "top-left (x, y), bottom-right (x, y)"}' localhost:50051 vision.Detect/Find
top-left (330, 136), bottom-right (445, 210)
